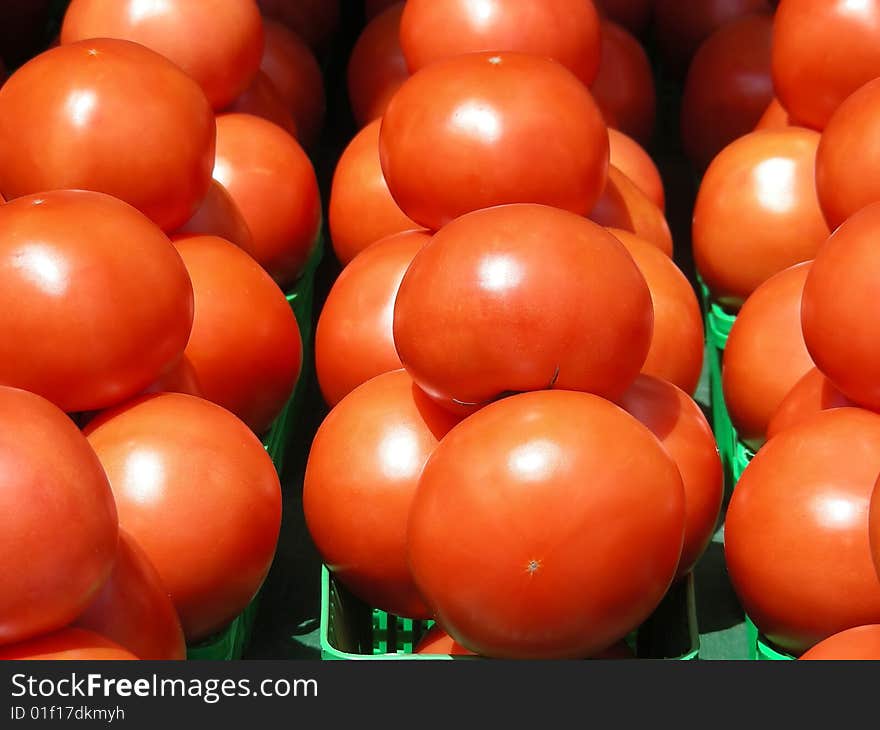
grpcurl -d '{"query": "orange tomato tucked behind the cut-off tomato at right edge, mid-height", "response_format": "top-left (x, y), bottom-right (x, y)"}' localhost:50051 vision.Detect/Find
top-left (721, 263), bottom-right (813, 448)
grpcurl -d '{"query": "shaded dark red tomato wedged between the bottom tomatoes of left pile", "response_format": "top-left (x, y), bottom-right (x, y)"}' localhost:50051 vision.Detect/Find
top-left (74, 531), bottom-right (186, 661)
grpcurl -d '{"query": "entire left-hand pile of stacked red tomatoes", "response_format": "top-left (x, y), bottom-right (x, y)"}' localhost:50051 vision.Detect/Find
top-left (0, 0), bottom-right (332, 659)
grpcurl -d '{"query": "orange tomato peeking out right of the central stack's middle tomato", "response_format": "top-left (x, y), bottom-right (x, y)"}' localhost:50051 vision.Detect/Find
top-left (609, 228), bottom-right (703, 393)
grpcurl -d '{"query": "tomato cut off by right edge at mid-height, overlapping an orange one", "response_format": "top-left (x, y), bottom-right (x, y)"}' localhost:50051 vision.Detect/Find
top-left (800, 203), bottom-right (880, 410)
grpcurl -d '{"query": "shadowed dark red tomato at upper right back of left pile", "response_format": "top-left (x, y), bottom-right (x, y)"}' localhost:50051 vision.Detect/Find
top-left (260, 20), bottom-right (326, 147)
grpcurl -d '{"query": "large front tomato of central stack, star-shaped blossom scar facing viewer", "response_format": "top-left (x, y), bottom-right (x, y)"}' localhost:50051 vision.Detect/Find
top-left (408, 391), bottom-right (685, 658)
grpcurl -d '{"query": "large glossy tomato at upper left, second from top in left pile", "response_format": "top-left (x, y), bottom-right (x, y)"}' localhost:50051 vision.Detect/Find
top-left (0, 38), bottom-right (215, 231)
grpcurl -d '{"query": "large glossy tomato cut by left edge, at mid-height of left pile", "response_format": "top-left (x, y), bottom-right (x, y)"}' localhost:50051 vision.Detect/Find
top-left (0, 190), bottom-right (193, 411)
